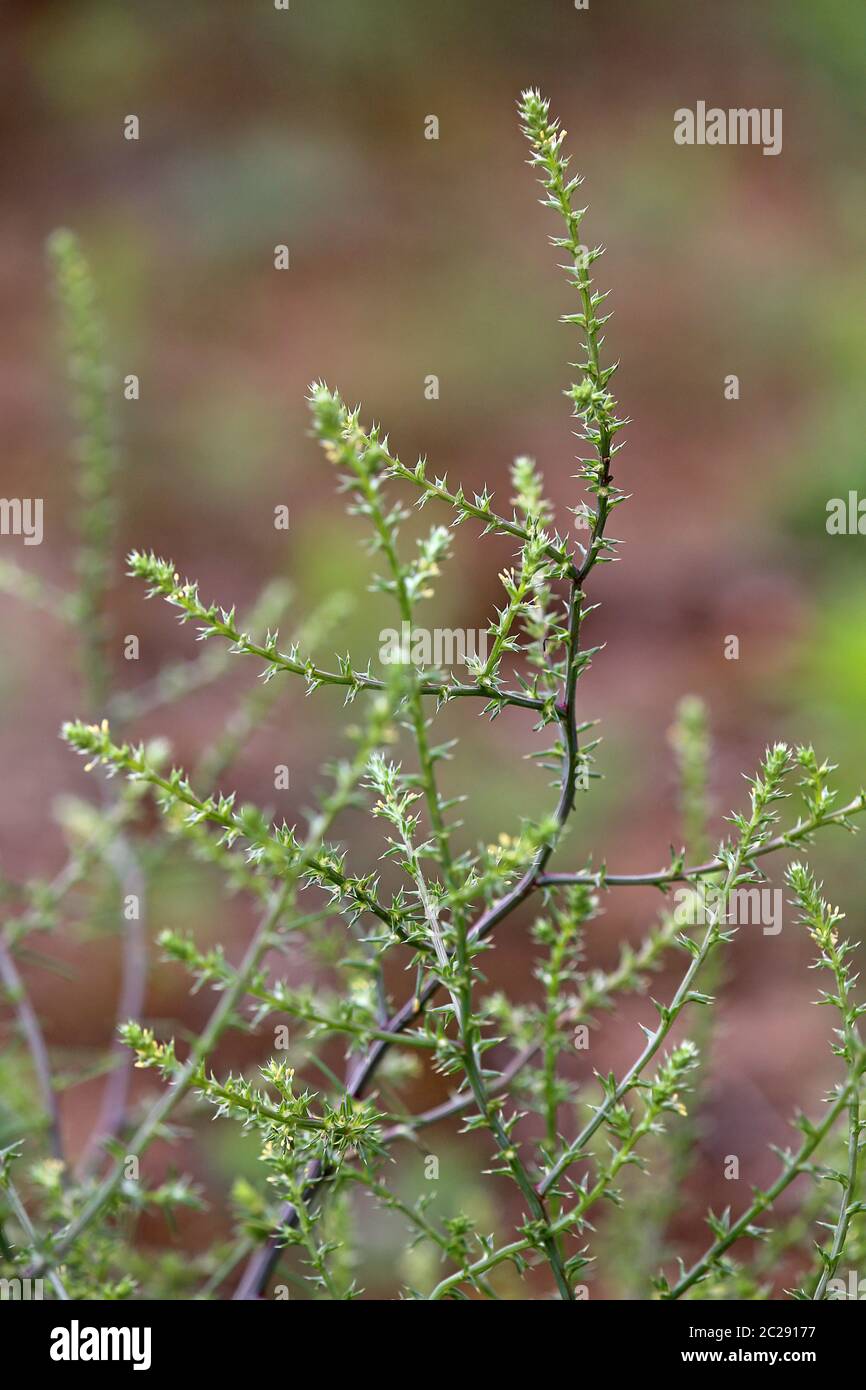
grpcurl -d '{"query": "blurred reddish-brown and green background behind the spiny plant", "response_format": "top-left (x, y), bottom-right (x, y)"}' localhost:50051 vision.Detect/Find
top-left (0, 0), bottom-right (866, 1297)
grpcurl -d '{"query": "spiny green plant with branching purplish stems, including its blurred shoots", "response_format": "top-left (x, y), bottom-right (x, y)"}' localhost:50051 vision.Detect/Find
top-left (0, 92), bottom-right (866, 1301)
